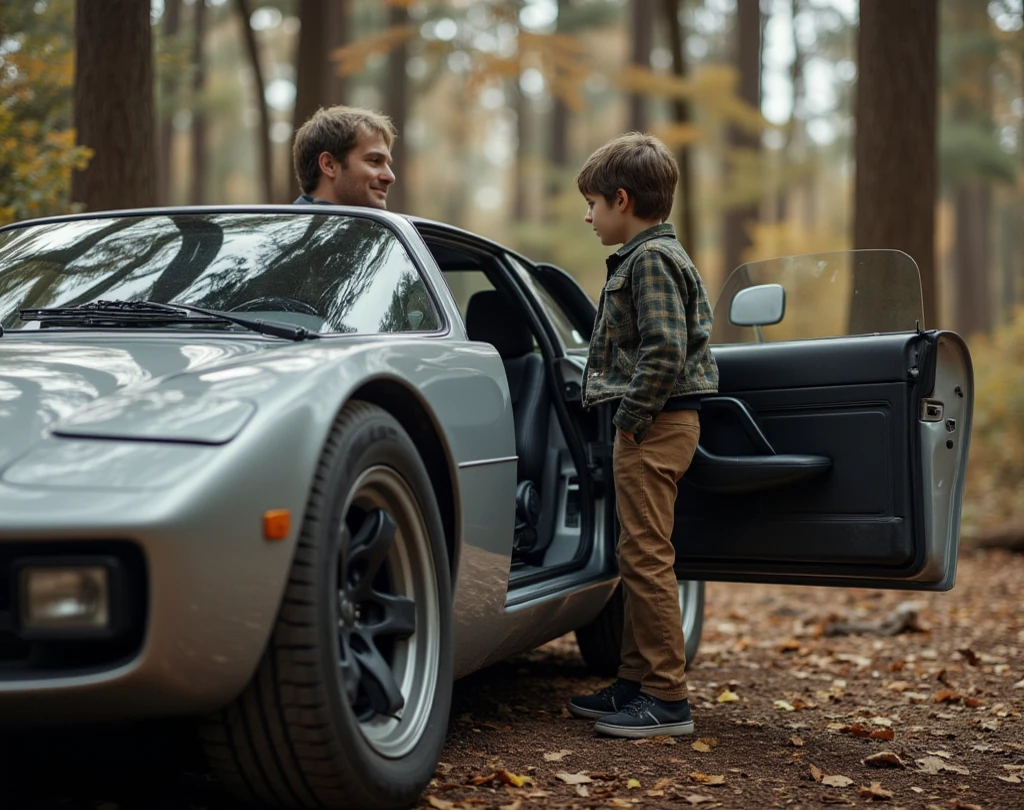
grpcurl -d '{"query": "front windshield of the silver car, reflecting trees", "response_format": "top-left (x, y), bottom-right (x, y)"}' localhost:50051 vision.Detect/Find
top-left (0, 212), bottom-right (440, 334)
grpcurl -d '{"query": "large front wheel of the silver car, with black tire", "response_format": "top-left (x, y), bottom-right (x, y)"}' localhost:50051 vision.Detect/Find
top-left (203, 401), bottom-right (453, 810)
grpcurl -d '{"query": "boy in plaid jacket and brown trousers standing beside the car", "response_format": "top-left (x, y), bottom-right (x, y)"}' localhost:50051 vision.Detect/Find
top-left (568, 132), bottom-right (718, 738)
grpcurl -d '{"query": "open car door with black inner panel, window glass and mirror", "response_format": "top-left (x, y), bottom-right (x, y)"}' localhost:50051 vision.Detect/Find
top-left (673, 250), bottom-right (974, 590)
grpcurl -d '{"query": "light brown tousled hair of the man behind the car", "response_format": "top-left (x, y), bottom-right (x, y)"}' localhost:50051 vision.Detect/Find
top-left (292, 104), bottom-right (397, 194)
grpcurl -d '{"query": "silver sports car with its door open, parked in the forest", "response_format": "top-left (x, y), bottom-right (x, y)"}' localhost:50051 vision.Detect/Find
top-left (0, 206), bottom-right (973, 808)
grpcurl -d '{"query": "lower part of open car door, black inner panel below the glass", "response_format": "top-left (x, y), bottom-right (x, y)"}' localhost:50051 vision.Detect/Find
top-left (673, 332), bottom-right (971, 589)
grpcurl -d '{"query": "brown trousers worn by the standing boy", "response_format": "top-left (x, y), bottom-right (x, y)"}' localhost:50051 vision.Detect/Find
top-left (612, 411), bottom-right (700, 700)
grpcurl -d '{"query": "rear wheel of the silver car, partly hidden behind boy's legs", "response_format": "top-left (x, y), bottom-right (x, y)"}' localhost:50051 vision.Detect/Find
top-left (575, 580), bottom-right (705, 678)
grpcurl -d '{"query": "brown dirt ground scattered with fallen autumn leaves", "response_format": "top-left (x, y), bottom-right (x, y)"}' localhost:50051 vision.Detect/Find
top-left (9, 551), bottom-right (1024, 810)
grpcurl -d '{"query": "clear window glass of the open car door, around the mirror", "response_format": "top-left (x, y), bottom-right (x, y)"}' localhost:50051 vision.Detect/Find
top-left (712, 250), bottom-right (925, 344)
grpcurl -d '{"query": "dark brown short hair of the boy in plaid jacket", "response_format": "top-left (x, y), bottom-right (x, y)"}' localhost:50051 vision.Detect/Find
top-left (577, 132), bottom-right (679, 222)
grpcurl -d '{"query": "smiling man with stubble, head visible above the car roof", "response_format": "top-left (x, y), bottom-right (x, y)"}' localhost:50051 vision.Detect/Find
top-left (292, 105), bottom-right (397, 208)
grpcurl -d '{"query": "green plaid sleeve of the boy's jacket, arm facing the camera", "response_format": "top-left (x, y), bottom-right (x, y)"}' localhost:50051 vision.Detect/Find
top-left (612, 249), bottom-right (687, 441)
